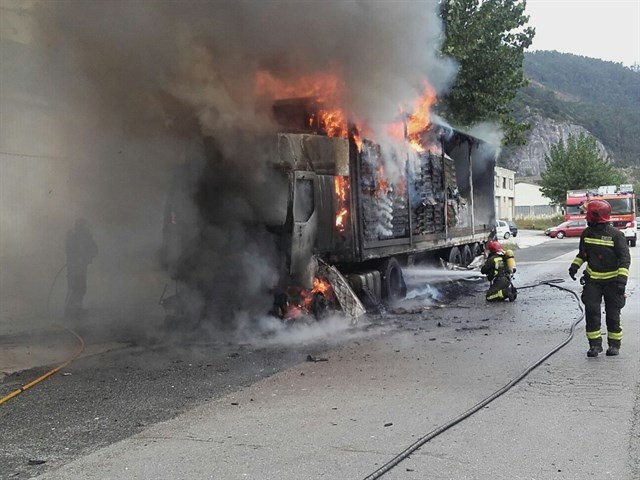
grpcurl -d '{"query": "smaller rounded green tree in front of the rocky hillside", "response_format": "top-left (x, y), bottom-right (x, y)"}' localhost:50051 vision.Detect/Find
top-left (540, 133), bottom-right (622, 205)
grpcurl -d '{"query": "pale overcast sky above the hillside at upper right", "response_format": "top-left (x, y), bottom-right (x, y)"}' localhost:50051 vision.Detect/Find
top-left (526, 0), bottom-right (640, 66)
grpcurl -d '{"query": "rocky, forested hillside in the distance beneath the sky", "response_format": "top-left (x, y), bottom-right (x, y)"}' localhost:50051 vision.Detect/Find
top-left (500, 52), bottom-right (640, 177)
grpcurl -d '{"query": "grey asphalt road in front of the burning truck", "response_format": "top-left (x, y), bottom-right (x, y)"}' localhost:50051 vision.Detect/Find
top-left (0, 239), bottom-right (640, 480)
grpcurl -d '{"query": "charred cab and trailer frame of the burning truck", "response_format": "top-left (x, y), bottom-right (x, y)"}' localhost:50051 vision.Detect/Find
top-left (274, 99), bottom-right (496, 316)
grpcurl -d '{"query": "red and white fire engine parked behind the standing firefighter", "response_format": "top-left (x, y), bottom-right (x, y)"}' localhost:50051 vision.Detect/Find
top-left (564, 185), bottom-right (637, 247)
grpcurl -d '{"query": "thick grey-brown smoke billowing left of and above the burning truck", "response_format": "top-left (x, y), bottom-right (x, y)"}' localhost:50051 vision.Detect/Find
top-left (0, 0), bottom-right (454, 330)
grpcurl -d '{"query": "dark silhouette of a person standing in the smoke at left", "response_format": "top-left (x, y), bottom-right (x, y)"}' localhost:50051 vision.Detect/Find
top-left (65, 218), bottom-right (98, 315)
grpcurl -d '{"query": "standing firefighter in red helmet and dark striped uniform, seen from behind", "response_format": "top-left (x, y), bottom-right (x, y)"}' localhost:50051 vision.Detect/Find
top-left (569, 200), bottom-right (631, 357)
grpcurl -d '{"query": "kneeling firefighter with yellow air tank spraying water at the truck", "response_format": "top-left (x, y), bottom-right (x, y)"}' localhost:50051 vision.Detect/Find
top-left (480, 241), bottom-right (518, 302)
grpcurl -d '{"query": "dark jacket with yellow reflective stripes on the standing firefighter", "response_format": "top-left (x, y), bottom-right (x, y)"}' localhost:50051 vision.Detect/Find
top-left (571, 223), bottom-right (631, 285)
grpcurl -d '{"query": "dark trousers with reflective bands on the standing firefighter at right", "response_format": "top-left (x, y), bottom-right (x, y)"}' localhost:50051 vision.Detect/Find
top-left (582, 280), bottom-right (625, 347)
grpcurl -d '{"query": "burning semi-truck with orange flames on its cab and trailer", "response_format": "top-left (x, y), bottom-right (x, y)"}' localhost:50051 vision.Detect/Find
top-left (163, 97), bottom-right (496, 319)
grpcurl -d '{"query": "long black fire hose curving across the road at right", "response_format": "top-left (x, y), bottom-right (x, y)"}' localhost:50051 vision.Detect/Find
top-left (363, 279), bottom-right (584, 480)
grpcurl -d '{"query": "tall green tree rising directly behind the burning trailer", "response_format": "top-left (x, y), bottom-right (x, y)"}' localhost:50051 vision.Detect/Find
top-left (440, 0), bottom-right (535, 145)
